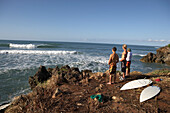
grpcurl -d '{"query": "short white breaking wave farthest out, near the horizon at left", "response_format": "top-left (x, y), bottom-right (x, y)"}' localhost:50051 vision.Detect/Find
top-left (9, 43), bottom-right (36, 49)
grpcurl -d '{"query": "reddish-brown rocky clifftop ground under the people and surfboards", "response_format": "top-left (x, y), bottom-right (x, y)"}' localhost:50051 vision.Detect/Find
top-left (3, 65), bottom-right (170, 113)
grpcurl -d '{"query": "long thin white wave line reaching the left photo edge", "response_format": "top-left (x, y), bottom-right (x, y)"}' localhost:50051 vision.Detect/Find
top-left (0, 50), bottom-right (77, 54)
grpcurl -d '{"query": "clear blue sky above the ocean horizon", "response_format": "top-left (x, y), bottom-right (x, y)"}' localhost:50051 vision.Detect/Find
top-left (0, 0), bottom-right (170, 45)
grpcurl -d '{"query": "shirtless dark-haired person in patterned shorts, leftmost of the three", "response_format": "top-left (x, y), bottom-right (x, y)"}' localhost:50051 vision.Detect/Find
top-left (107, 47), bottom-right (119, 84)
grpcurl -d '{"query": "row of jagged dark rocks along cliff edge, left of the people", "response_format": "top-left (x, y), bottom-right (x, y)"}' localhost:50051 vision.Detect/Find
top-left (29, 65), bottom-right (92, 89)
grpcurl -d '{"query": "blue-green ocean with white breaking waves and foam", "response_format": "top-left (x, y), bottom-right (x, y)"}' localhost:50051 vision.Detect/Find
top-left (0, 40), bottom-right (170, 105)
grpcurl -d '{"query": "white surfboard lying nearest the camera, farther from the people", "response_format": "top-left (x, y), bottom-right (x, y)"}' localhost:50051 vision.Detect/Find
top-left (140, 86), bottom-right (161, 102)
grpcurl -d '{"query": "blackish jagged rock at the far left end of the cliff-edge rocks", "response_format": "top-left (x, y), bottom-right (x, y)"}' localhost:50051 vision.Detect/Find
top-left (29, 66), bottom-right (51, 89)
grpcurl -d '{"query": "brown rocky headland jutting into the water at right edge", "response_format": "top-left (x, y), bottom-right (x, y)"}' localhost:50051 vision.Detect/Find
top-left (140, 44), bottom-right (170, 65)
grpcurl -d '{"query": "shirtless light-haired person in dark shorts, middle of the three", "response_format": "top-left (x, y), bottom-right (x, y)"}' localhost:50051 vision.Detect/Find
top-left (120, 44), bottom-right (127, 79)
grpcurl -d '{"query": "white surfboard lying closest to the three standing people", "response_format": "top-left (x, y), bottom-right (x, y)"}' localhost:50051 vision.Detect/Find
top-left (120, 79), bottom-right (152, 90)
